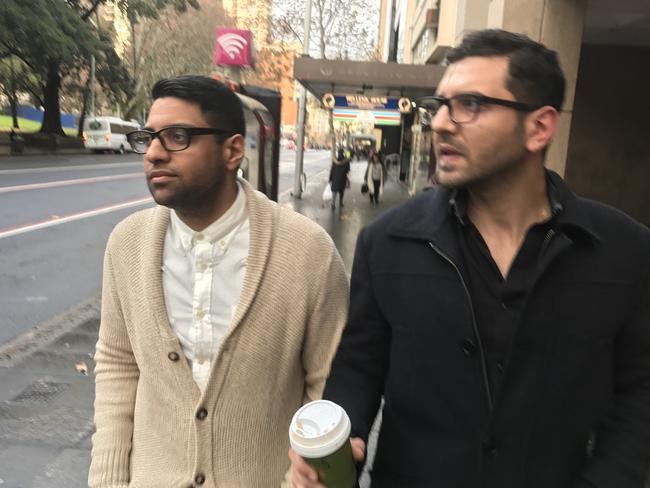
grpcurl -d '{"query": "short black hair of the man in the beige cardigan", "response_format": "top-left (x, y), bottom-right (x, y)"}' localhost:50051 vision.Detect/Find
top-left (151, 75), bottom-right (246, 136)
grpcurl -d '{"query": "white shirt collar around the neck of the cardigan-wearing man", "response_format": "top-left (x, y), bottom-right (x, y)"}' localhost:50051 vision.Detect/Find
top-left (169, 182), bottom-right (248, 252)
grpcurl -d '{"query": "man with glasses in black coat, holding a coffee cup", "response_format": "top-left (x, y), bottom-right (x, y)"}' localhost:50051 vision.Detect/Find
top-left (290, 30), bottom-right (650, 488)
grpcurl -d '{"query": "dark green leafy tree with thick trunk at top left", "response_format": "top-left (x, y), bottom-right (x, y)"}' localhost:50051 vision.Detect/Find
top-left (0, 0), bottom-right (198, 134)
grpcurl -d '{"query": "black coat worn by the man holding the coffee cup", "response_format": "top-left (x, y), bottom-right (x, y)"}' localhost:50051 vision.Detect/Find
top-left (324, 172), bottom-right (650, 488)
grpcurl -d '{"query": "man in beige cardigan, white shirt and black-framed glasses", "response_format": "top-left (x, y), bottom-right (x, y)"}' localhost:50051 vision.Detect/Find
top-left (89, 76), bottom-right (348, 488)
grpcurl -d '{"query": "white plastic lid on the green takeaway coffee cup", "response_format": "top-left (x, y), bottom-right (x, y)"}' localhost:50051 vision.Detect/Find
top-left (289, 400), bottom-right (351, 458)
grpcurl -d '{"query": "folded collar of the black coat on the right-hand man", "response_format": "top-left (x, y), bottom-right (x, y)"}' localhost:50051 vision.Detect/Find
top-left (387, 170), bottom-right (600, 248)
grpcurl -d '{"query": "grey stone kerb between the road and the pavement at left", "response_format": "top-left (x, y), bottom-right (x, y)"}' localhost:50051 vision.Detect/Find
top-left (0, 294), bottom-right (101, 367)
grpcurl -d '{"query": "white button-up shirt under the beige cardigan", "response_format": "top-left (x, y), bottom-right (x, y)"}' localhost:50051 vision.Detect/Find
top-left (162, 183), bottom-right (250, 391)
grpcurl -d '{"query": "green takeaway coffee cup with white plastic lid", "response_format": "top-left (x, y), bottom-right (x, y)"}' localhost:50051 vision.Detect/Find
top-left (289, 400), bottom-right (357, 488)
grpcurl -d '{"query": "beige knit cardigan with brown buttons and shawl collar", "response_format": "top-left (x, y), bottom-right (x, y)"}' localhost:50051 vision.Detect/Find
top-left (88, 182), bottom-right (348, 488)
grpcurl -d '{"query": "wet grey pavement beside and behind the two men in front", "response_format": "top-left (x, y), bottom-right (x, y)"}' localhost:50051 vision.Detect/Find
top-left (0, 161), bottom-right (408, 488)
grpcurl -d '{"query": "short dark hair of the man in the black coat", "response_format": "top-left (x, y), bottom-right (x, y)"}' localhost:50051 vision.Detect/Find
top-left (447, 29), bottom-right (566, 111)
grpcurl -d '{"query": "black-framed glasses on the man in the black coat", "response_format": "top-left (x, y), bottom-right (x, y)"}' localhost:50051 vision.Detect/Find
top-left (416, 93), bottom-right (543, 126)
